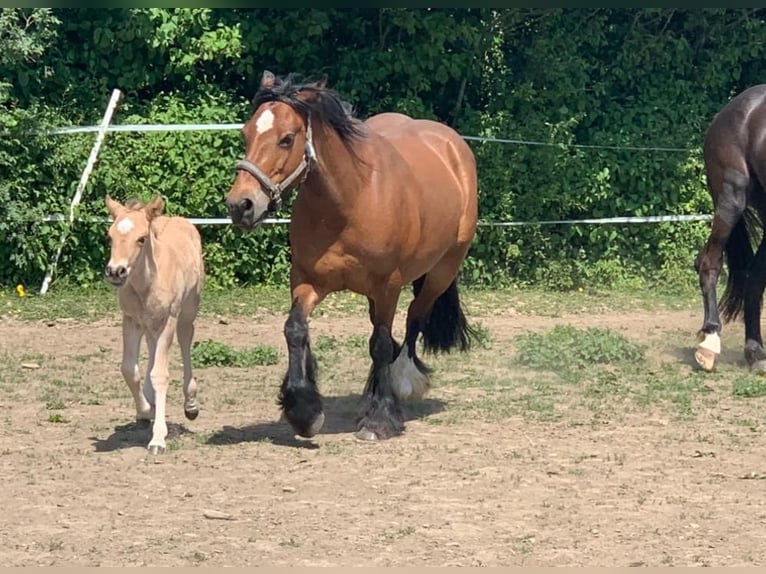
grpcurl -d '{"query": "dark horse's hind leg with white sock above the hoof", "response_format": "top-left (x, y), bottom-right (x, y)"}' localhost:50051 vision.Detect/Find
top-left (694, 166), bottom-right (750, 371)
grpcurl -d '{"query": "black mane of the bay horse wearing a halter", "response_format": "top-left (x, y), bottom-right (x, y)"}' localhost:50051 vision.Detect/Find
top-left (253, 74), bottom-right (363, 144)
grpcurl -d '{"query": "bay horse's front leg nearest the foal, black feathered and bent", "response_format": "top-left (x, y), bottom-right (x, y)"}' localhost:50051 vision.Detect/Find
top-left (279, 283), bottom-right (324, 438)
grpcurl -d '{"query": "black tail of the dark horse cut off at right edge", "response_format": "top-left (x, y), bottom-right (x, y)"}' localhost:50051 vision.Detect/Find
top-left (718, 208), bottom-right (762, 323)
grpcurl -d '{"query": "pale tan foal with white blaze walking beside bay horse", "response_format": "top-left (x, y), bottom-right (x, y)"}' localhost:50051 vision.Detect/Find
top-left (105, 196), bottom-right (205, 454)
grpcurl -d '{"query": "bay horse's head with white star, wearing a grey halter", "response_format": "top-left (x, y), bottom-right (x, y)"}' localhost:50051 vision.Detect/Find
top-left (226, 71), bottom-right (325, 229)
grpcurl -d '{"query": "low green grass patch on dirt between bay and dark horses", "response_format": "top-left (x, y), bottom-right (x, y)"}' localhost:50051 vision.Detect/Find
top-left (514, 325), bottom-right (644, 374)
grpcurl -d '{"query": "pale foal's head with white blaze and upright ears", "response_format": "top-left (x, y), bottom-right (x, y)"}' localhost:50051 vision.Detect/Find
top-left (104, 195), bottom-right (165, 287)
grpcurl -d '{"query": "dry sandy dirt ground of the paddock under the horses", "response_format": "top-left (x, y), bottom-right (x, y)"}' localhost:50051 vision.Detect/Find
top-left (0, 304), bottom-right (766, 566)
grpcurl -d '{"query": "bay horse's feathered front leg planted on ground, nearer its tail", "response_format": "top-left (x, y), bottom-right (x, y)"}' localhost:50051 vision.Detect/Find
top-left (356, 289), bottom-right (404, 440)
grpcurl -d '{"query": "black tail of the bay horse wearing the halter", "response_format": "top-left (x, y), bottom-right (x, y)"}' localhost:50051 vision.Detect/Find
top-left (412, 277), bottom-right (476, 354)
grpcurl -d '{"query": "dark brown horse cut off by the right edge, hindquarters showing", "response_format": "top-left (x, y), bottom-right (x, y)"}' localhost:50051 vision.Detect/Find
top-left (695, 85), bottom-right (766, 371)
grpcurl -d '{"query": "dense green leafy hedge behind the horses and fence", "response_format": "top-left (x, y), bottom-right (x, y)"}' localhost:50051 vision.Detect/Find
top-left (0, 8), bottom-right (766, 289)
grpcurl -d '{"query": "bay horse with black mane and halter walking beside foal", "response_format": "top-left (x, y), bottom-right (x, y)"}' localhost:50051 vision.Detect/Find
top-left (226, 71), bottom-right (477, 440)
